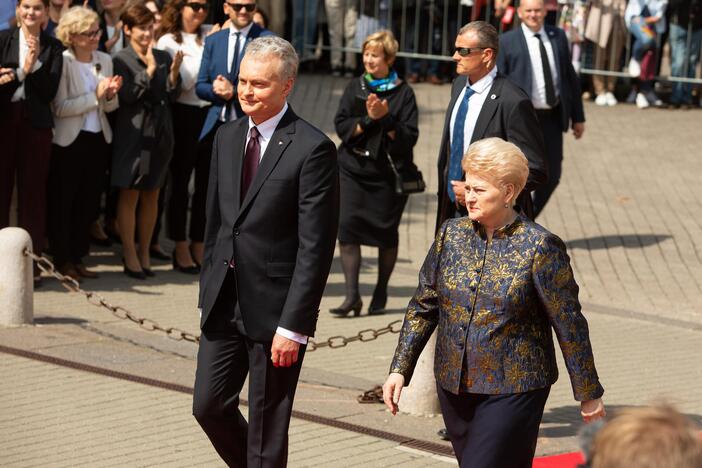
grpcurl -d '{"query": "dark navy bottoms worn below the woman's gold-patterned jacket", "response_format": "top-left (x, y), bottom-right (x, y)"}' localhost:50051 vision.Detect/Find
top-left (437, 384), bottom-right (551, 468)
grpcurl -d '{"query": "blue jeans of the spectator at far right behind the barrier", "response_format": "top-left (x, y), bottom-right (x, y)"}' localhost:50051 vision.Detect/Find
top-left (668, 24), bottom-right (702, 104)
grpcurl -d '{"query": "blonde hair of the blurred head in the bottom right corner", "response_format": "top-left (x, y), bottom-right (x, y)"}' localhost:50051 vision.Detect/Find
top-left (589, 404), bottom-right (702, 468)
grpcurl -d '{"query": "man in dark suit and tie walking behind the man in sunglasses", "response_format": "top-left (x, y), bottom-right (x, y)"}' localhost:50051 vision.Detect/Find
top-left (497, 0), bottom-right (585, 217)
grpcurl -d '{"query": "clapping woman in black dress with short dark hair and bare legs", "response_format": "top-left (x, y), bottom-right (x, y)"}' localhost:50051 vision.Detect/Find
top-left (111, 3), bottom-right (183, 279)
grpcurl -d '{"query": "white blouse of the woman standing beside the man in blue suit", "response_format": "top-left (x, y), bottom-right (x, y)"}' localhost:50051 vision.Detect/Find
top-left (156, 31), bottom-right (210, 107)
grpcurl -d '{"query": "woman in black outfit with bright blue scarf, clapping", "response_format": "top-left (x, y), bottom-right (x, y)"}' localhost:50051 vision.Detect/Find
top-left (330, 31), bottom-right (419, 316)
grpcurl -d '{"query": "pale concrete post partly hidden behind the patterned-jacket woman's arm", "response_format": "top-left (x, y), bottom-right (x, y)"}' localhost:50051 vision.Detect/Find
top-left (399, 332), bottom-right (441, 416)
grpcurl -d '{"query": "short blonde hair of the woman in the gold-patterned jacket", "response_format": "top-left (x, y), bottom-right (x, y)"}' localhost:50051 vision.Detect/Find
top-left (461, 137), bottom-right (529, 198)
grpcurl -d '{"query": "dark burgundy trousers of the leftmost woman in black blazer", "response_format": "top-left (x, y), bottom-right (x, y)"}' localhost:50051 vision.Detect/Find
top-left (0, 101), bottom-right (52, 254)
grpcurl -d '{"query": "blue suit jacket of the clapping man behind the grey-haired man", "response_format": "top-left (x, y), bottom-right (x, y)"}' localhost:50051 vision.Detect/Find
top-left (195, 23), bottom-right (275, 140)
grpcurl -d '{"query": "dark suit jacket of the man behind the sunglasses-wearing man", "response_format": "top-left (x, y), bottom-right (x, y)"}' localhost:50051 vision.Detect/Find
top-left (497, 25), bottom-right (585, 132)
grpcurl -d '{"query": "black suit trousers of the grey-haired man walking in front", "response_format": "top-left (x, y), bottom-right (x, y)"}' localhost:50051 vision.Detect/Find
top-left (193, 270), bottom-right (305, 468)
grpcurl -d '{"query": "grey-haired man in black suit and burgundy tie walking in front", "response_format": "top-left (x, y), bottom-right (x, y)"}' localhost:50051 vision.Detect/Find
top-left (193, 36), bottom-right (339, 468)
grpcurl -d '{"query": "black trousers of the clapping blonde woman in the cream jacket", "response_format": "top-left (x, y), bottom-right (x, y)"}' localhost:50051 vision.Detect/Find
top-left (47, 131), bottom-right (109, 266)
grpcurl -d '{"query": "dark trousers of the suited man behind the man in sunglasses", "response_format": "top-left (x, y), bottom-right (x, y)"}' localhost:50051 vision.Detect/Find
top-left (534, 107), bottom-right (563, 218)
